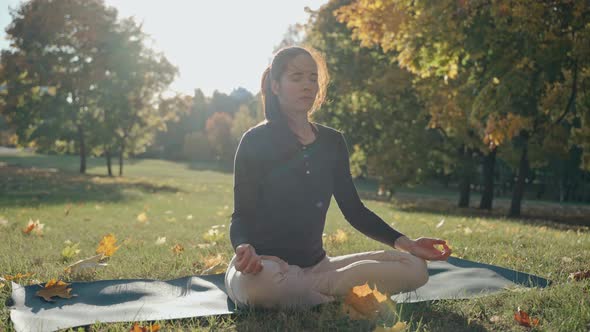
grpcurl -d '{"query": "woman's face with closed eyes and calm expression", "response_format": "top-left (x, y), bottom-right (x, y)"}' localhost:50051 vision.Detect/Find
top-left (271, 54), bottom-right (319, 114)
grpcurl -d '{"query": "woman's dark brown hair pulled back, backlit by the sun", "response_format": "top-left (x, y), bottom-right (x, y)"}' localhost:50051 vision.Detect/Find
top-left (260, 46), bottom-right (329, 122)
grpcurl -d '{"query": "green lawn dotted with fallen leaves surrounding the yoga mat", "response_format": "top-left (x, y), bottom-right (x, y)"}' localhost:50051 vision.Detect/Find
top-left (0, 153), bottom-right (590, 331)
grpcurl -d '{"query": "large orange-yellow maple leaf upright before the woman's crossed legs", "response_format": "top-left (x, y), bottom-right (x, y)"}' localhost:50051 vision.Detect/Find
top-left (343, 283), bottom-right (395, 319)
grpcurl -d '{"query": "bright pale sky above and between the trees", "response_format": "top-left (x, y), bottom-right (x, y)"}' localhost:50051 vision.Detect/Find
top-left (0, 0), bottom-right (327, 96)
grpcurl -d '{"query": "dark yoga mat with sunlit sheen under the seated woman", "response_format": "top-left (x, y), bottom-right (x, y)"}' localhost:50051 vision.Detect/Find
top-left (7, 257), bottom-right (549, 332)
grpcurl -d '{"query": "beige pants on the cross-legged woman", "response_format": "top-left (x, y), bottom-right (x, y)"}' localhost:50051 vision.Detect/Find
top-left (225, 250), bottom-right (428, 308)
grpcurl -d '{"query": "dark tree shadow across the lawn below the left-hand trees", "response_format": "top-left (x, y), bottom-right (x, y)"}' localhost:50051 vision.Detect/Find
top-left (0, 166), bottom-right (181, 207)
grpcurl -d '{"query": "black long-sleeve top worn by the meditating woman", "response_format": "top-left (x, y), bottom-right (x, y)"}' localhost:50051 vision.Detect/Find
top-left (230, 122), bottom-right (403, 267)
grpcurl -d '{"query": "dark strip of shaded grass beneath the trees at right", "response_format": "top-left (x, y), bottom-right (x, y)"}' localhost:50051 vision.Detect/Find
top-left (359, 192), bottom-right (590, 231)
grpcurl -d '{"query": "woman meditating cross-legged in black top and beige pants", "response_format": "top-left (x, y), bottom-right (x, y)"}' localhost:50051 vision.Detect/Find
top-left (225, 47), bottom-right (451, 308)
